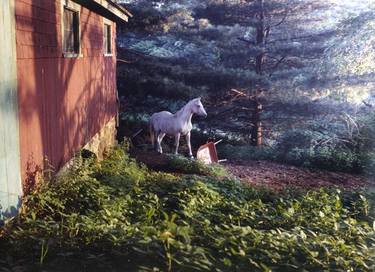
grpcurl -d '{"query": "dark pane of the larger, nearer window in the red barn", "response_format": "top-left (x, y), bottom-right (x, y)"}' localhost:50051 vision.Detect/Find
top-left (63, 7), bottom-right (80, 55)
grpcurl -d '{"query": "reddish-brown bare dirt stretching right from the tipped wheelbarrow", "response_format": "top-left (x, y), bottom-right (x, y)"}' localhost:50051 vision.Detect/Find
top-left (224, 161), bottom-right (370, 189)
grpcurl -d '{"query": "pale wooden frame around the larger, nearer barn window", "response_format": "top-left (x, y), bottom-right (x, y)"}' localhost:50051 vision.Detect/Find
top-left (61, 0), bottom-right (83, 58)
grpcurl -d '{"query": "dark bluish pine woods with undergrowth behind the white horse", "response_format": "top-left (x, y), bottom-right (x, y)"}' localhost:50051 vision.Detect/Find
top-left (118, 0), bottom-right (375, 174)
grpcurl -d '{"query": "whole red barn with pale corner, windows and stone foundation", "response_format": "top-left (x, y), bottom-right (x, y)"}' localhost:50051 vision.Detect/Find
top-left (0, 0), bottom-right (131, 218)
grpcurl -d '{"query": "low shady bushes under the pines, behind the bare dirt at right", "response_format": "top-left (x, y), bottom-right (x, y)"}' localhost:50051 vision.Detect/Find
top-left (219, 111), bottom-right (375, 176)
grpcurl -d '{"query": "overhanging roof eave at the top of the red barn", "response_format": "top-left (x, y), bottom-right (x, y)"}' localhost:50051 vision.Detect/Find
top-left (74, 0), bottom-right (133, 22)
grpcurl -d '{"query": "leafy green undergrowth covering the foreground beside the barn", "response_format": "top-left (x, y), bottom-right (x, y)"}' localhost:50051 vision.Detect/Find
top-left (0, 148), bottom-right (375, 271)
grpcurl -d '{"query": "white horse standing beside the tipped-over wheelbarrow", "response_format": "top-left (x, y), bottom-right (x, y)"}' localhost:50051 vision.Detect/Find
top-left (150, 98), bottom-right (207, 157)
